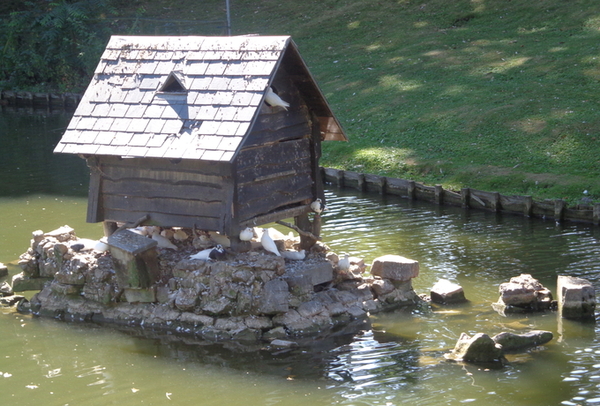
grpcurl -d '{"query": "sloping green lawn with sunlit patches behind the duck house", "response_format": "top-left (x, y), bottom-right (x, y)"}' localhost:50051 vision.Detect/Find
top-left (79, 0), bottom-right (600, 203)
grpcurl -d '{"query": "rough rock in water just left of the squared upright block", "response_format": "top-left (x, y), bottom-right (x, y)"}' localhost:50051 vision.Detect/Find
top-left (493, 274), bottom-right (552, 314)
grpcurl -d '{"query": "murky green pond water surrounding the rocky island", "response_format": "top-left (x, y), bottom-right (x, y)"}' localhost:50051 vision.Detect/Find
top-left (0, 110), bottom-right (600, 406)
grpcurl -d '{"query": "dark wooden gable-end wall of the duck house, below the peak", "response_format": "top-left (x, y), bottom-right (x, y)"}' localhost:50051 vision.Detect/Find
top-left (235, 78), bottom-right (316, 222)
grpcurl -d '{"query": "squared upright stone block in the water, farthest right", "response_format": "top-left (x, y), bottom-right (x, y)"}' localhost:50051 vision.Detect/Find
top-left (556, 275), bottom-right (596, 319)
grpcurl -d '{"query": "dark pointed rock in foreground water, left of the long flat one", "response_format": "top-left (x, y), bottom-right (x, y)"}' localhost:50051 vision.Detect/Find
top-left (444, 333), bottom-right (503, 362)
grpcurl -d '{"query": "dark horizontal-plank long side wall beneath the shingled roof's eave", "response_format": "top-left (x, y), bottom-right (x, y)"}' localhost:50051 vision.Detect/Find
top-left (88, 156), bottom-right (233, 231)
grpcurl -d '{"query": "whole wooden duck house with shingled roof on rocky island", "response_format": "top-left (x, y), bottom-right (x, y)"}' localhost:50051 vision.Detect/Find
top-left (54, 36), bottom-right (346, 243)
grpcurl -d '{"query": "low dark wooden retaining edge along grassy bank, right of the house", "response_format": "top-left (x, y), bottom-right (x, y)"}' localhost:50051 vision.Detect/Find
top-left (321, 168), bottom-right (600, 225)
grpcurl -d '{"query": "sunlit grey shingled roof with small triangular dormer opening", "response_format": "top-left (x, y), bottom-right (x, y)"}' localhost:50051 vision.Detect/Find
top-left (54, 36), bottom-right (346, 162)
